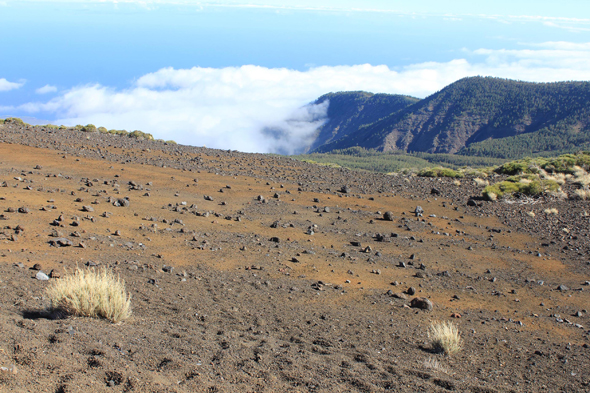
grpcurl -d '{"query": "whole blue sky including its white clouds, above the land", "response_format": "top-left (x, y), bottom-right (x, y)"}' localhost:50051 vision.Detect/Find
top-left (0, 0), bottom-right (590, 151)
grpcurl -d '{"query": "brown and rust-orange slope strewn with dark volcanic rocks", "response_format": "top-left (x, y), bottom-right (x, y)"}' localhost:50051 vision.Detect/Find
top-left (0, 123), bottom-right (590, 393)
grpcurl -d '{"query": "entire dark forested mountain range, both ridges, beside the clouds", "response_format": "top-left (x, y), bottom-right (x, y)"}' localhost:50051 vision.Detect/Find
top-left (310, 77), bottom-right (590, 158)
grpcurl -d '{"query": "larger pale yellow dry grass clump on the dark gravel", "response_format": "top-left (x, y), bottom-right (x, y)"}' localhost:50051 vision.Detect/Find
top-left (46, 269), bottom-right (131, 323)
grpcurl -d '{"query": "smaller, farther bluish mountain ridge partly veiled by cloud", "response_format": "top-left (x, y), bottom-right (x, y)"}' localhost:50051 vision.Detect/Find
top-left (308, 91), bottom-right (420, 151)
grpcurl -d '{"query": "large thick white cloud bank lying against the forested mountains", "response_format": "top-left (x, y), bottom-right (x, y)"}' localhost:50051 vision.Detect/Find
top-left (10, 42), bottom-right (590, 153)
